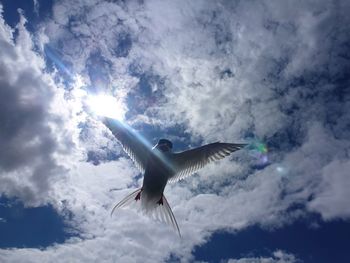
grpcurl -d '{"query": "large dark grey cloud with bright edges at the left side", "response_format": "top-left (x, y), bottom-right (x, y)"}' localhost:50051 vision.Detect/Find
top-left (0, 7), bottom-right (81, 205)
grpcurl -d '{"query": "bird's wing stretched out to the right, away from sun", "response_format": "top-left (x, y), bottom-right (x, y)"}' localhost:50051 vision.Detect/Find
top-left (169, 142), bottom-right (247, 182)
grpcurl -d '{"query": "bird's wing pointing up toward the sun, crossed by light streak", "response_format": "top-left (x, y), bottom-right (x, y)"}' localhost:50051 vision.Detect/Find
top-left (103, 117), bottom-right (152, 173)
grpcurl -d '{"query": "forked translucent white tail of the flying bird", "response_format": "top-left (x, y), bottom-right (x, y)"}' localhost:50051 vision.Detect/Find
top-left (111, 188), bottom-right (181, 237)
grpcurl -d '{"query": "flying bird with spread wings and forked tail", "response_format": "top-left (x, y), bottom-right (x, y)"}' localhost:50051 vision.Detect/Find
top-left (102, 117), bottom-right (247, 237)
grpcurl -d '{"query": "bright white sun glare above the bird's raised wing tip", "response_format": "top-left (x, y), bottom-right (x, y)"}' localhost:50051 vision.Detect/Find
top-left (87, 95), bottom-right (125, 120)
